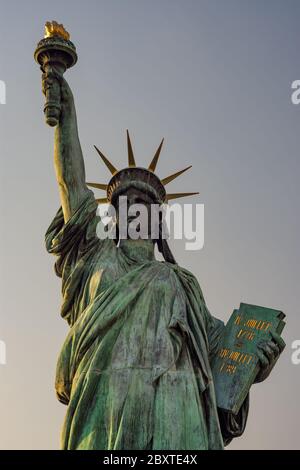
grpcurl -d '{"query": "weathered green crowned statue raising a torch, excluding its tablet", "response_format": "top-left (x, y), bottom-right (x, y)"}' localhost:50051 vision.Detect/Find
top-left (35, 22), bottom-right (284, 450)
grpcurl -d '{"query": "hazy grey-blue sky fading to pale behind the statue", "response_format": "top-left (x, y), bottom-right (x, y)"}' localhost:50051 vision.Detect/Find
top-left (0, 0), bottom-right (300, 449)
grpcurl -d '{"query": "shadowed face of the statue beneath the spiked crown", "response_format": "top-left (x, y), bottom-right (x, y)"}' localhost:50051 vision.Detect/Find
top-left (116, 188), bottom-right (154, 238)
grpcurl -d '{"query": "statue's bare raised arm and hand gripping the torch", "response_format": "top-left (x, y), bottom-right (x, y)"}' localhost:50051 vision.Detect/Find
top-left (43, 71), bottom-right (89, 222)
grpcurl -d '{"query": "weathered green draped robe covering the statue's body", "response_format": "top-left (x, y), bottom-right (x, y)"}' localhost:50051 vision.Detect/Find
top-left (46, 191), bottom-right (248, 450)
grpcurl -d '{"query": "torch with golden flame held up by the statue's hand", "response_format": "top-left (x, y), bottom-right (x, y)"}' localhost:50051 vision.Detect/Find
top-left (34, 21), bottom-right (77, 127)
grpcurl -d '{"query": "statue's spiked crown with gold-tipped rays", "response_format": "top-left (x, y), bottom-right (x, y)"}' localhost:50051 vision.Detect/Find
top-left (86, 130), bottom-right (199, 204)
